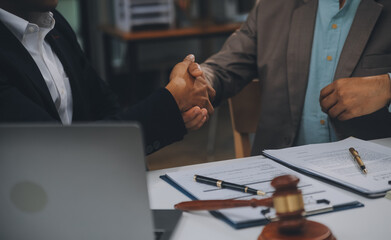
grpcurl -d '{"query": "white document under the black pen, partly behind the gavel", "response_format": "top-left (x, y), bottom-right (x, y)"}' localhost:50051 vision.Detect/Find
top-left (166, 156), bottom-right (361, 228)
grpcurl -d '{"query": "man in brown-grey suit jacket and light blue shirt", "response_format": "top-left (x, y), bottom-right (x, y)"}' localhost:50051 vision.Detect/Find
top-left (192, 0), bottom-right (391, 154)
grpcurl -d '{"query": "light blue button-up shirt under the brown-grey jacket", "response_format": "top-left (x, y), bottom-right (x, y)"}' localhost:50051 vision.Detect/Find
top-left (296, 0), bottom-right (376, 145)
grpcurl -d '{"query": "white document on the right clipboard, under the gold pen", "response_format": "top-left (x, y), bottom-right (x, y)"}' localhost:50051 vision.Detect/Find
top-left (264, 137), bottom-right (391, 197)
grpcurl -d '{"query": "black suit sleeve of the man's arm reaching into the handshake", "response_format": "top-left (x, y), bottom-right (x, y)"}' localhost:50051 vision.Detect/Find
top-left (57, 13), bottom-right (187, 154)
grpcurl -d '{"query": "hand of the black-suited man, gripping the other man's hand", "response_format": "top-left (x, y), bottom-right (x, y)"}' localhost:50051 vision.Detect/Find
top-left (166, 55), bottom-right (215, 115)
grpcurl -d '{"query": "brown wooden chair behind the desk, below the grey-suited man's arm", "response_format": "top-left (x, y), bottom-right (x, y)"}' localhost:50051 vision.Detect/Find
top-left (228, 79), bottom-right (261, 158)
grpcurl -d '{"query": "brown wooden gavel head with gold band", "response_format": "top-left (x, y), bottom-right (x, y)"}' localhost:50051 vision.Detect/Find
top-left (271, 175), bottom-right (306, 233)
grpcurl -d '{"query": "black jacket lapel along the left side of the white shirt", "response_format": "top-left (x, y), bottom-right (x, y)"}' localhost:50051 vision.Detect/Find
top-left (0, 22), bottom-right (60, 120)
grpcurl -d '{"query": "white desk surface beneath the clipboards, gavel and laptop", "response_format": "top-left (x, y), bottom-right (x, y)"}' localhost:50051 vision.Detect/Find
top-left (147, 138), bottom-right (391, 240)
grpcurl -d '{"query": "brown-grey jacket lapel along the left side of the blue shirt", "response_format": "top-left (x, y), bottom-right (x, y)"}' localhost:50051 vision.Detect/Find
top-left (287, 0), bottom-right (318, 125)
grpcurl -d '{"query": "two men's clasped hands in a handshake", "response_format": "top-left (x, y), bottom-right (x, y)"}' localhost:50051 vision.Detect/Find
top-left (166, 54), bottom-right (216, 130)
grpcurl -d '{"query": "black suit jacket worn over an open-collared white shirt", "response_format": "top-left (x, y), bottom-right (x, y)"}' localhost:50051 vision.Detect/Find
top-left (0, 11), bottom-right (186, 153)
